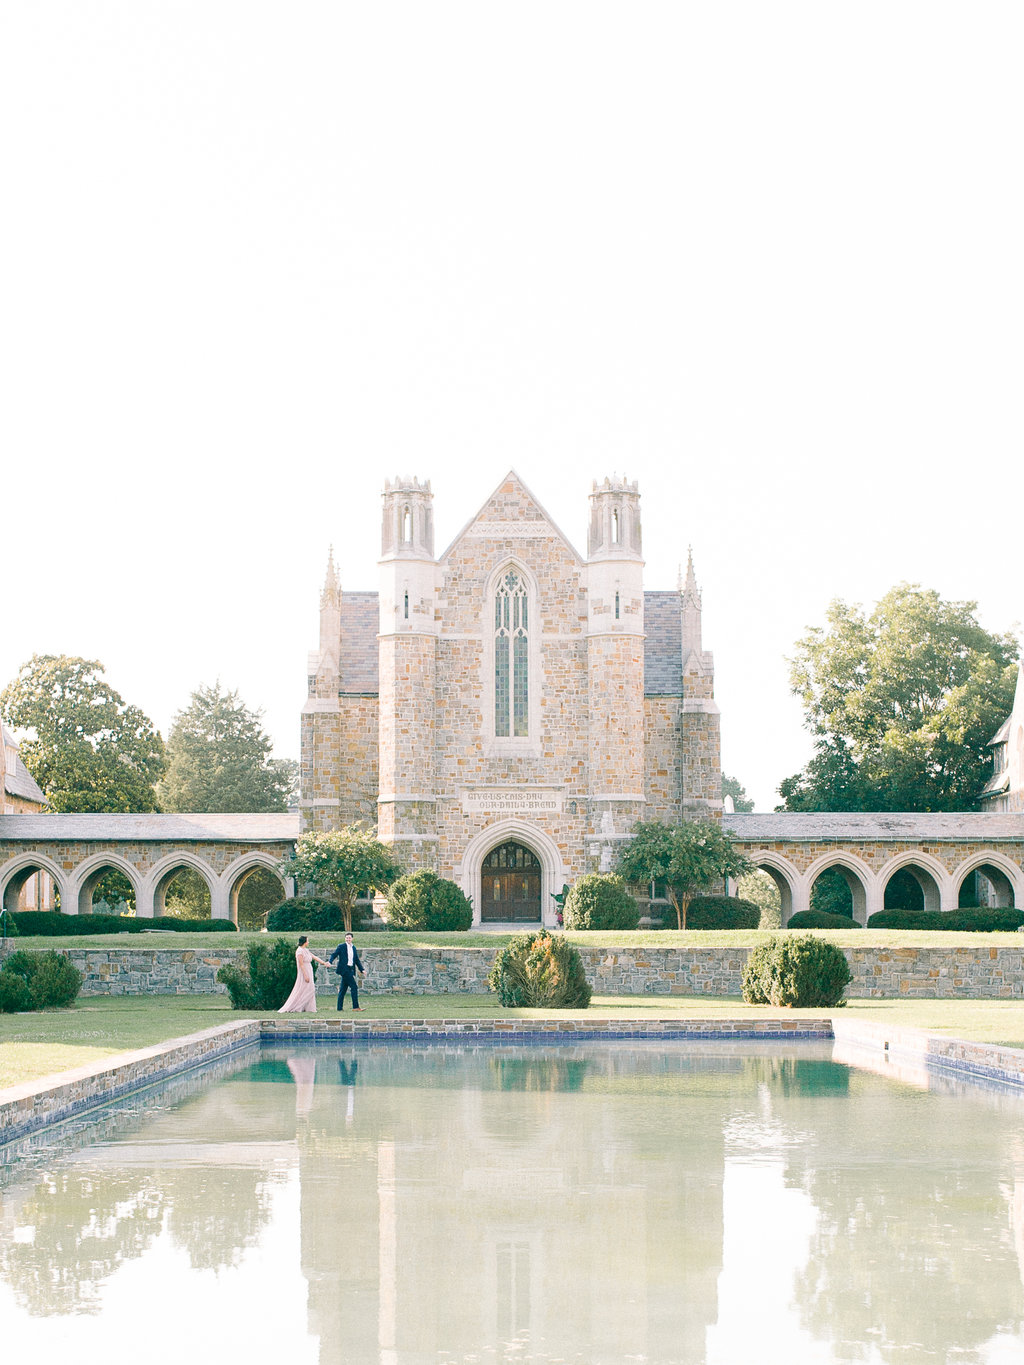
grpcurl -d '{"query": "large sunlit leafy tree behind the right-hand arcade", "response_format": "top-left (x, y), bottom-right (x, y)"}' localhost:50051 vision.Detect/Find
top-left (780, 583), bottom-right (1019, 811)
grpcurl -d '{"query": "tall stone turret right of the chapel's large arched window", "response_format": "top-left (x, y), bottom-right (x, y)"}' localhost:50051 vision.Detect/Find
top-left (587, 478), bottom-right (644, 838)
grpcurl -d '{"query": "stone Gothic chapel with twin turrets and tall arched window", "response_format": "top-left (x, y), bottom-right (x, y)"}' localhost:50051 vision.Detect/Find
top-left (300, 471), bottom-right (722, 924)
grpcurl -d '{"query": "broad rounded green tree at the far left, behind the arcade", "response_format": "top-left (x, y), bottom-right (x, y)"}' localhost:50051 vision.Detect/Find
top-left (0, 654), bottom-right (167, 811)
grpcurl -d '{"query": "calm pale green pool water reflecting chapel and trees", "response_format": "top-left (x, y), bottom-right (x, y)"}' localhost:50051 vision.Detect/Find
top-left (0, 1044), bottom-right (1024, 1365)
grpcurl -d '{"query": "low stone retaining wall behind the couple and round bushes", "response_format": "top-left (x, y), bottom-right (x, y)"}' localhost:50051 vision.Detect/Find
top-left (0, 935), bottom-right (1024, 999)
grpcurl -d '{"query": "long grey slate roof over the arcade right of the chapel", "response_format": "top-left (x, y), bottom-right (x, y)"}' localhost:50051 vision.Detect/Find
top-left (722, 811), bottom-right (1024, 844)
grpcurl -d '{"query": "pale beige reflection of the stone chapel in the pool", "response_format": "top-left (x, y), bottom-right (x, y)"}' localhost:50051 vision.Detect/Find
top-left (299, 1050), bottom-right (722, 1365)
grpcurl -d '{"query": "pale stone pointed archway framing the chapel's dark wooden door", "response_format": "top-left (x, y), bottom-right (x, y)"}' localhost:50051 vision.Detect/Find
top-left (456, 819), bottom-right (568, 927)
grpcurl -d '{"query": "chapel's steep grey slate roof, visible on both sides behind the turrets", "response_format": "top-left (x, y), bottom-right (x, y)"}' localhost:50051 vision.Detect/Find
top-left (339, 592), bottom-right (683, 696)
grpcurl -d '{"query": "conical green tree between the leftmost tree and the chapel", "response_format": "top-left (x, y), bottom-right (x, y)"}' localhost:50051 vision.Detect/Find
top-left (160, 681), bottom-right (295, 811)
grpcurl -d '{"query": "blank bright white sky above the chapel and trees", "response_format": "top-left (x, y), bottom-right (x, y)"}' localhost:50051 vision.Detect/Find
top-left (0, 0), bottom-right (1024, 809)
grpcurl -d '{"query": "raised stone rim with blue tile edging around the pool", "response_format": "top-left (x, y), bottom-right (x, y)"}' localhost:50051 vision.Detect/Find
top-left (0, 1016), bottom-right (1024, 1147)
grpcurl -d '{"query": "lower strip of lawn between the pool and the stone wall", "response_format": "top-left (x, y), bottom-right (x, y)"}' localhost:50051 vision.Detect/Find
top-left (0, 988), bottom-right (1024, 1088)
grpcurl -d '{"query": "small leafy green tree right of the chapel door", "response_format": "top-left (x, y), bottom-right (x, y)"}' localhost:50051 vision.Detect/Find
top-left (617, 820), bottom-right (751, 930)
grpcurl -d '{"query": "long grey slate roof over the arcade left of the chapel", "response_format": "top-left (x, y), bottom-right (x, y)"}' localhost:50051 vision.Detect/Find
top-left (0, 811), bottom-right (299, 844)
